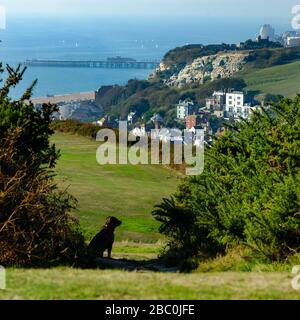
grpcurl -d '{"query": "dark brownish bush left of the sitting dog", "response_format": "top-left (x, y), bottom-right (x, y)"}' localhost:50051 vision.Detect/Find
top-left (0, 63), bottom-right (85, 267)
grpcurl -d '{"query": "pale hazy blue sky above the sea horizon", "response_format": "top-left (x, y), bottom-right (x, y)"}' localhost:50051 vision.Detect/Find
top-left (0, 0), bottom-right (300, 19)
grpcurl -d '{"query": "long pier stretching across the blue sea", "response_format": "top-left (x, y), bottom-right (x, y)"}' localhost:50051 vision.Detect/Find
top-left (24, 57), bottom-right (159, 69)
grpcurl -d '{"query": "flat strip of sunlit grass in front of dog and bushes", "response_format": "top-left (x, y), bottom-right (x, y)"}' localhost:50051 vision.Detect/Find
top-left (0, 269), bottom-right (300, 300)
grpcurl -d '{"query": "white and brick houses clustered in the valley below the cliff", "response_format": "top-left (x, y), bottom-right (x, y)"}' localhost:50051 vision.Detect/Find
top-left (97, 89), bottom-right (261, 143)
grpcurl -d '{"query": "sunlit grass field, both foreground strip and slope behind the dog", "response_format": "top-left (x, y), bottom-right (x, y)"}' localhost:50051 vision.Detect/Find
top-left (0, 134), bottom-right (300, 300)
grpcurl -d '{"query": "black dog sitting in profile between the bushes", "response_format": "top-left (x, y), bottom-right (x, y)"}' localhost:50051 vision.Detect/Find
top-left (88, 217), bottom-right (122, 259)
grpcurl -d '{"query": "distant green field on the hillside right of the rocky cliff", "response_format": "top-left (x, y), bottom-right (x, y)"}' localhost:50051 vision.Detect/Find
top-left (245, 61), bottom-right (300, 97)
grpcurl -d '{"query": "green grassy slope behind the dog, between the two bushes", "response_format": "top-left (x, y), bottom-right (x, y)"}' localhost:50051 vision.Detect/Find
top-left (53, 134), bottom-right (180, 242)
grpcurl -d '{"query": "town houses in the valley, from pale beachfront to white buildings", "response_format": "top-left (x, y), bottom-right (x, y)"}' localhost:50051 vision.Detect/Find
top-left (33, 88), bottom-right (263, 143)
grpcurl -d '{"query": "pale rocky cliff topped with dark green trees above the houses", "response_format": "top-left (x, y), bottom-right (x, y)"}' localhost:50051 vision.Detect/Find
top-left (149, 40), bottom-right (300, 88)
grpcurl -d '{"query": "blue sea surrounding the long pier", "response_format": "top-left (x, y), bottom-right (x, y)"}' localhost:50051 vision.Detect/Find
top-left (0, 15), bottom-right (290, 98)
